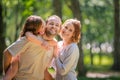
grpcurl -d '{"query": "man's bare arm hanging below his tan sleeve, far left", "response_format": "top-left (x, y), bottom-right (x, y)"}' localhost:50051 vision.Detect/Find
top-left (3, 49), bottom-right (12, 73)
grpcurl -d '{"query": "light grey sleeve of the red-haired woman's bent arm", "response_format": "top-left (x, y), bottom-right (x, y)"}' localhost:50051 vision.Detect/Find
top-left (55, 45), bottom-right (79, 75)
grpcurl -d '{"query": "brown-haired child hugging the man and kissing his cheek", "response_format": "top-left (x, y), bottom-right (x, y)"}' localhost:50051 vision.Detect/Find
top-left (3, 15), bottom-right (45, 80)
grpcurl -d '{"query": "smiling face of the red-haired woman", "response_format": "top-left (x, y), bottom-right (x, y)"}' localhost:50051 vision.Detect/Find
top-left (60, 22), bottom-right (75, 41)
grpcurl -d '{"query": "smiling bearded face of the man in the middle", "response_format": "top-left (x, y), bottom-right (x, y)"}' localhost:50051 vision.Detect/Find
top-left (45, 17), bottom-right (61, 36)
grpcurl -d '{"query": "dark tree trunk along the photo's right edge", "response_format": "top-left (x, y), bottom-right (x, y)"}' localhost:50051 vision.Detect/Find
top-left (112, 0), bottom-right (120, 71)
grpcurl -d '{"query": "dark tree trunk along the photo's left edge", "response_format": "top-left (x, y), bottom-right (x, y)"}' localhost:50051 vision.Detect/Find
top-left (0, 0), bottom-right (6, 74)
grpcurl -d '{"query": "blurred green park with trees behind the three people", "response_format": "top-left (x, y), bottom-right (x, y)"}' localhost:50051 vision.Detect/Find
top-left (0, 0), bottom-right (120, 80)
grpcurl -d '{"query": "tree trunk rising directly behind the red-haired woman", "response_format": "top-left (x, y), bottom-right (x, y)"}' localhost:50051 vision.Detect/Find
top-left (65, 0), bottom-right (86, 76)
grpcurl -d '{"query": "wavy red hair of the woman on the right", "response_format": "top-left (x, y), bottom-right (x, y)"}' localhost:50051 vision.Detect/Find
top-left (63, 19), bottom-right (81, 42)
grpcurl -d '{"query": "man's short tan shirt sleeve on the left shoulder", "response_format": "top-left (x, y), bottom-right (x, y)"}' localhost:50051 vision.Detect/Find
top-left (7, 37), bottom-right (28, 56)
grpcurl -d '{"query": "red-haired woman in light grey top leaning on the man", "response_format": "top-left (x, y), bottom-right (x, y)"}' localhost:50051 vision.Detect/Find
top-left (54, 19), bottom-right (81, 80)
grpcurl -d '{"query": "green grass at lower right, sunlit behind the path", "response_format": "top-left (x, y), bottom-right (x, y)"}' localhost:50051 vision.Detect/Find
top-left (82, 54), bottom-right (120, 80)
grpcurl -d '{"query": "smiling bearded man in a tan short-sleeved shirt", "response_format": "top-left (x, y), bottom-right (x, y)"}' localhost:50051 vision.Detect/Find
top-left (4, 15), bottom-right (61, 80)
